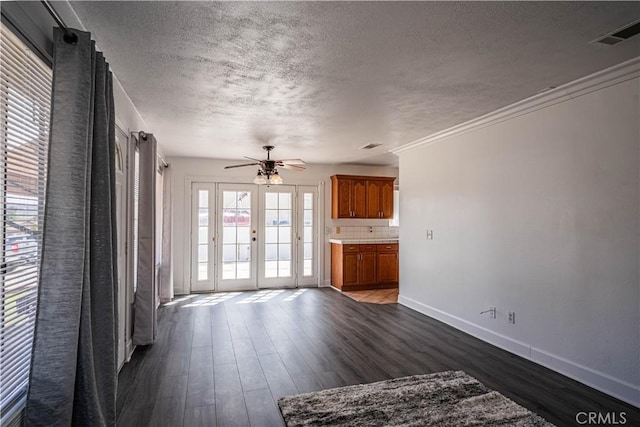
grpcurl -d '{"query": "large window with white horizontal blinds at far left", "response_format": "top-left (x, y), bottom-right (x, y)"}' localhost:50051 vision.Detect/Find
top-left (0, 24), bottom-right (52, 424)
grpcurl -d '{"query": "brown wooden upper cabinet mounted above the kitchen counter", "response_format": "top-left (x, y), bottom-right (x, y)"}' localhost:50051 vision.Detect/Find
top-left (331, 175), bottom-right (395, 219)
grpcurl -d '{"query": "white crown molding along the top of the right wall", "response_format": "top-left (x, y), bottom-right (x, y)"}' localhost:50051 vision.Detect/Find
top-left (390, 56), bottom-right (640, 155)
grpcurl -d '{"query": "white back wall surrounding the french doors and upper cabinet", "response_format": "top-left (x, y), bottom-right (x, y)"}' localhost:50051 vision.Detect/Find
top-left (167, 155), bottom-right (398, 295)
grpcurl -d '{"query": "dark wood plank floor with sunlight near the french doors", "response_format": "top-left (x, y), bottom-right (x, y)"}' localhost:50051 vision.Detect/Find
top-left (118, 289), bottom-right (640, 427)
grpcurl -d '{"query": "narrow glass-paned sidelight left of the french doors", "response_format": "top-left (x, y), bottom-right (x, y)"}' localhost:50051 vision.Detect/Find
top-left (191, 183), bottom-right (215, 292)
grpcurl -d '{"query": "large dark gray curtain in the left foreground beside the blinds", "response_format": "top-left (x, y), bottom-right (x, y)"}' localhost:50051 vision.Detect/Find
top-left (25, 28), bottom-right (118, 426)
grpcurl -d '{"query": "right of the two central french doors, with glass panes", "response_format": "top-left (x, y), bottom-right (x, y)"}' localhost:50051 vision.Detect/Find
top-left (258, 185), bottom-right (296, 288)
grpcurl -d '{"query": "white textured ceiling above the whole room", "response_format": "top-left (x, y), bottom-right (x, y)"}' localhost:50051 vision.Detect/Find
top-left (70, 2), bottom-right (640, 164)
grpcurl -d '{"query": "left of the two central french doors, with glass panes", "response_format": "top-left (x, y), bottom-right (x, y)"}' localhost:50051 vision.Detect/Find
top-left (218, 184), bottom-right (258, 291)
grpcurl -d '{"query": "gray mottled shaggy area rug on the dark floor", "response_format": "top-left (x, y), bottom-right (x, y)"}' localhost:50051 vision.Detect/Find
top-left (278, 371), bottom-right (553, 427)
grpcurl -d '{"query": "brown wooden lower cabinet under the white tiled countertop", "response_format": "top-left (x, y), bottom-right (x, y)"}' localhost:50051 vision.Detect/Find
top-left (331, 243), bottom-right (399, 291)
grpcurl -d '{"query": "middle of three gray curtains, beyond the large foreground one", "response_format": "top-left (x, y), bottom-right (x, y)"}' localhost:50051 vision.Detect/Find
top-left (133, 132), bottom-right (158, 345)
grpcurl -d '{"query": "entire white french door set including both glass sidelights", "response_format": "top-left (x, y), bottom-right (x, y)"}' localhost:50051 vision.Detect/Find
top-left (191, 183), bottom-right (318, 292)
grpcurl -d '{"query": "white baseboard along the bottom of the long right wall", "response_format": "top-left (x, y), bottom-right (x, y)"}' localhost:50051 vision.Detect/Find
top-left (398, 295), bottom-right (640, 407)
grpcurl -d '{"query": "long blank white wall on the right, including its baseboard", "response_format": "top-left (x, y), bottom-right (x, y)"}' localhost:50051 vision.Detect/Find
top-left (399, 60), bottom-right (640, 405)
